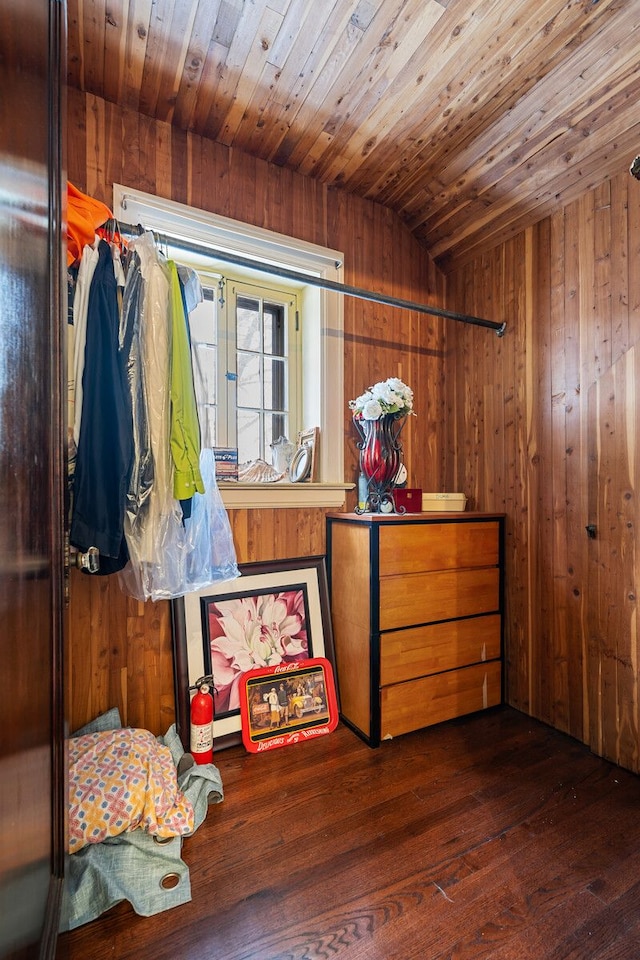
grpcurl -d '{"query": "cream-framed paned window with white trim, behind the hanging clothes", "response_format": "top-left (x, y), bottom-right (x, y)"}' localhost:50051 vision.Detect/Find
top-left (113, 184), bottom-right (350, 507)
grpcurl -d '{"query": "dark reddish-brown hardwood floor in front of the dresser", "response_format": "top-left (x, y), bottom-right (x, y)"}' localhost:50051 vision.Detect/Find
top-left (58, 708), bottom-right (640, 960)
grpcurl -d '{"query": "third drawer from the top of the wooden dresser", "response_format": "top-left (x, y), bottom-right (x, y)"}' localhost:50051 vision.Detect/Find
top-left (380, 613), bottom-right (500, 687)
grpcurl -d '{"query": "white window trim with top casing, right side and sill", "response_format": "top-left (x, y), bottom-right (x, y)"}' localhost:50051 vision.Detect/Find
top-left (113, 183), bottom-right (353, 509)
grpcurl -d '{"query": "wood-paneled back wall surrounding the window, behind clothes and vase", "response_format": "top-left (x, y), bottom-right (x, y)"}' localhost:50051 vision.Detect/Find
top-left (67, 90), bottom-right (445, 733)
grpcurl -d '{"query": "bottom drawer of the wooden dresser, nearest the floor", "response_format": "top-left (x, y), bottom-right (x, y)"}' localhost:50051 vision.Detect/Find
top-left (380, 660), bottom-right (502, 739)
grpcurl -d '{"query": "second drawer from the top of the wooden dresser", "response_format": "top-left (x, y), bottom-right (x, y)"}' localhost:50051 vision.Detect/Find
top-left (380, 567), bottom-right (500, 630)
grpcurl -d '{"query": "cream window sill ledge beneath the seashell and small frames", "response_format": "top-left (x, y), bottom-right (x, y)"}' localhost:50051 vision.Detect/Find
top-left (218, 480), bottom-right (355, 510)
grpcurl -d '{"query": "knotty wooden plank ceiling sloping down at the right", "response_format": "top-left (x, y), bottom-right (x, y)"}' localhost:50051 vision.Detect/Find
top-left (68, 0), bottom-right (640, 270)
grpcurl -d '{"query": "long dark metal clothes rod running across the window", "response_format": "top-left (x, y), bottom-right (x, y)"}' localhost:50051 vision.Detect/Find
top-left (116, 221), bottom-right (507, 337)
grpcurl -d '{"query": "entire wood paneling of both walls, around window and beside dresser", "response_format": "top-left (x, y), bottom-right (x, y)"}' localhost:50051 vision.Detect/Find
top-left (68, 99), bottom-right (640, 771)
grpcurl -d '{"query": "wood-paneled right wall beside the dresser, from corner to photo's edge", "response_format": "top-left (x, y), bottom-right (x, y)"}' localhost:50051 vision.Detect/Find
top-left (446, 167), bottom-right (640, 771)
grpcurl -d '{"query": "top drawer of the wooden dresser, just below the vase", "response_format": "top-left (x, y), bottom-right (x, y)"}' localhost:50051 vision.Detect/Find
top-left (379, 521), bottom-right (500, 577)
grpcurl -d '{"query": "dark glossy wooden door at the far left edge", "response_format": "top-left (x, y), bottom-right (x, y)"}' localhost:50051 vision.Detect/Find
top-left (0, 0), bottom-right (66, 960)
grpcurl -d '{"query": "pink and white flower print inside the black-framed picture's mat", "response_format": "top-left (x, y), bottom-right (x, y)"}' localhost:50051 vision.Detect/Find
top-left (207, 589), bottom-right (309, 716)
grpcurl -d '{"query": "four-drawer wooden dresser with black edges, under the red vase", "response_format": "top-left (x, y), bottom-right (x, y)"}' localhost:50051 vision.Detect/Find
top-left (327, 512), bottom-right (503, 747)
